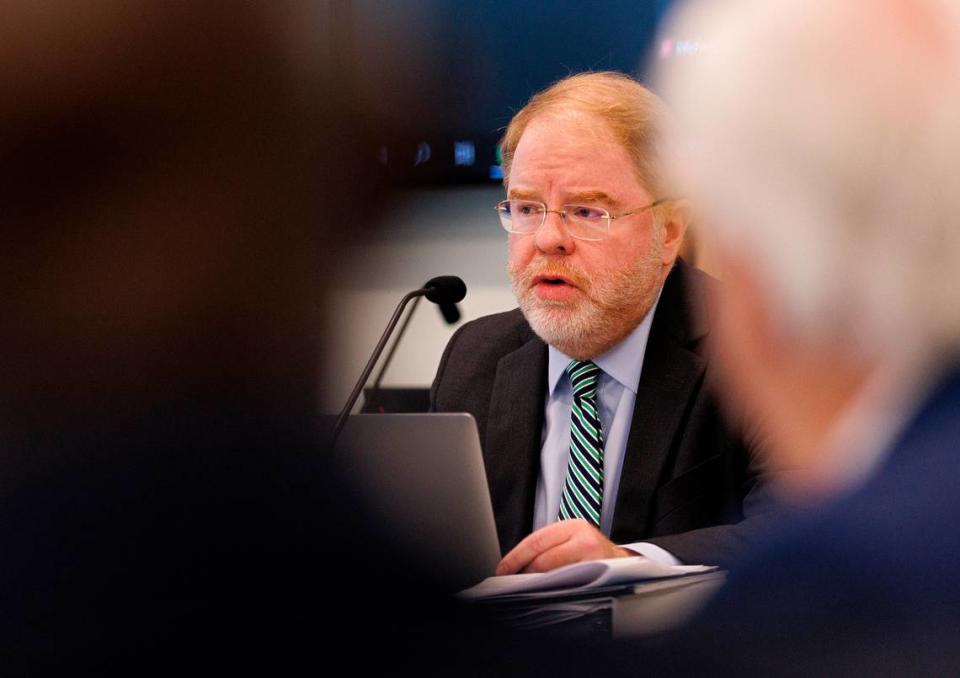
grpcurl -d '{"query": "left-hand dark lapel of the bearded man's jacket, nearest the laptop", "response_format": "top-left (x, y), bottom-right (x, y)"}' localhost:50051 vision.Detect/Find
top-left (484, 332), bottom-right (547, 553)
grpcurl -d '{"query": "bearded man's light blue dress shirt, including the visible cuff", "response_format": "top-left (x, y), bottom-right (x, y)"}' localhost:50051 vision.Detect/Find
top-left (533, 296), bottom-right (679, 565)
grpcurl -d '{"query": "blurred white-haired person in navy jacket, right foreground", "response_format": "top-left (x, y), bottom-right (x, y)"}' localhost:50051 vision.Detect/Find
top-left (584, 0), bottom-right (960, 675)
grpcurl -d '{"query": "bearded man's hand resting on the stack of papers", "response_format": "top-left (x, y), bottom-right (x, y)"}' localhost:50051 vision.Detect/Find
top-left (497, 519), bottom-right (637, 575)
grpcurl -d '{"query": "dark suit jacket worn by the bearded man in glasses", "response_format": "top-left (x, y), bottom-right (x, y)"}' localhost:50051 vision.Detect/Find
top-left (431, 261), bottom-right (768, 564)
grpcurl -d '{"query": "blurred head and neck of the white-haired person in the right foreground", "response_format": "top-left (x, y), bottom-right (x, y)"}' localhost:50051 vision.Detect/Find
top-left (659, 0), bottom-right (960, 495)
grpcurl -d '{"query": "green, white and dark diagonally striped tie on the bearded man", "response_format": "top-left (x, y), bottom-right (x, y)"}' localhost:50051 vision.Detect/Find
top-left (558, 360), bottom-right (603, 528)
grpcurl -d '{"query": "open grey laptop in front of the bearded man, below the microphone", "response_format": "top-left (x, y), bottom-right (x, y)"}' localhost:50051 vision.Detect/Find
top-left (336, 414), bottom-right (500, 591)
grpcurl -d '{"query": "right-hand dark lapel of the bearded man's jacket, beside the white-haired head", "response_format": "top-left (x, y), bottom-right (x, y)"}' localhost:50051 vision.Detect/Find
top-left (611, 261), bottom-right (706, 543)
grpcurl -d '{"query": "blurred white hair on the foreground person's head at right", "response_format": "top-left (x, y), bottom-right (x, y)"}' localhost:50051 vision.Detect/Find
top-left (655, 0), bottom-right (960, 364)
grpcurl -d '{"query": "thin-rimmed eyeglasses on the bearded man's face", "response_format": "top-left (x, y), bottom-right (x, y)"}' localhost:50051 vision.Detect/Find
top-left (494, 198), bottom-right (670, 240)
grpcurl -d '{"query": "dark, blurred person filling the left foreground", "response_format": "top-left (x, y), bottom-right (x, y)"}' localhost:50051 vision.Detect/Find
top-left (0, 0), bottom-right (498, 675)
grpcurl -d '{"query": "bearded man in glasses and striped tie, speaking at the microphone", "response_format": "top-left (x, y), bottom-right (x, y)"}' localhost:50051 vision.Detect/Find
top-left (431, 73), bottom-right (769, 574)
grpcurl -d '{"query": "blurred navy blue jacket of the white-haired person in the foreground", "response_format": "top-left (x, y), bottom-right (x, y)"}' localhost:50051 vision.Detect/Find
top-left (588, 365), bottom-right (960, 676)
